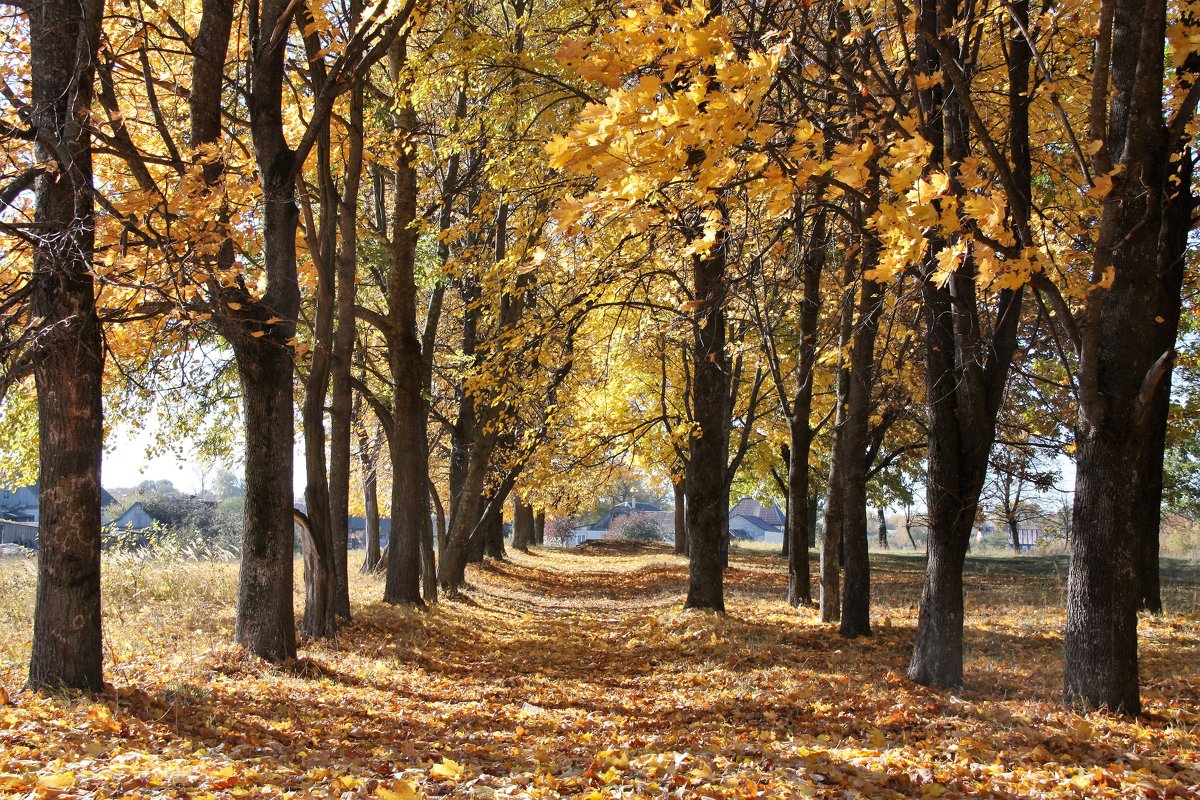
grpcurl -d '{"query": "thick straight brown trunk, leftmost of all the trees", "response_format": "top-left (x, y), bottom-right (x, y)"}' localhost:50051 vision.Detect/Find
top-left (28, 0), bottom-right (104, 691)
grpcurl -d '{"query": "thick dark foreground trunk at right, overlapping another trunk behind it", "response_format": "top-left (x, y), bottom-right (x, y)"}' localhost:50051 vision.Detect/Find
top-left (1063, 0), bottom-right (1196, 714)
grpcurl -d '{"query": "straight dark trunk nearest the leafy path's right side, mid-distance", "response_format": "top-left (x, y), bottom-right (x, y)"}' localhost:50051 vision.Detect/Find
top-left (685, 221), bottom-right (730, 612)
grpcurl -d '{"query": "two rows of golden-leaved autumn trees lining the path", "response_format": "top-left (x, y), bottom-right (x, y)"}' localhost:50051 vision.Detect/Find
top-left (0, 0), bottom-right (1200, 714)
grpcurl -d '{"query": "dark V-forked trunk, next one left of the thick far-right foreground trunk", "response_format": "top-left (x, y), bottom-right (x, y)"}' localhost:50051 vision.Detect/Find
top-left (907, 0), bottom-right (1033, 687)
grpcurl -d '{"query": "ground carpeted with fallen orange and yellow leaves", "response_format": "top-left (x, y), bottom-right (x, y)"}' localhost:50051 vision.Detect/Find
top-left (0, 546), bottom-right (1200, 800)
